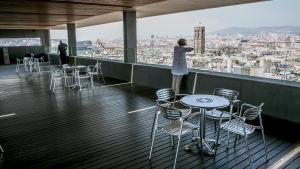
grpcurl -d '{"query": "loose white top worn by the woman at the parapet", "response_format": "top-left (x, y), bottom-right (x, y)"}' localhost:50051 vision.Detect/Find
top-left (171, 46), bottom-right (193, 75)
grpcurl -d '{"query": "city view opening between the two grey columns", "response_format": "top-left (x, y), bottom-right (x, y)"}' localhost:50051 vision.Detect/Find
top-left (76, 22), bottom-right (124, 61)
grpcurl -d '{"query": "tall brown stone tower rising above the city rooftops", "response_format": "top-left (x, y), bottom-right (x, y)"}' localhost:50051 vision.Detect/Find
top-left (194, 23), bottom-right (205, 55)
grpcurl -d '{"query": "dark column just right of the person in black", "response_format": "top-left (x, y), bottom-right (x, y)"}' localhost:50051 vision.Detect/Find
top-left (67, 23), bottom-right (77, 56)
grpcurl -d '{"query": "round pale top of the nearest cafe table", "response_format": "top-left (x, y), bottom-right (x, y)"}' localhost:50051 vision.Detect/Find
top-left (180, 94), bottom-right (229, 108)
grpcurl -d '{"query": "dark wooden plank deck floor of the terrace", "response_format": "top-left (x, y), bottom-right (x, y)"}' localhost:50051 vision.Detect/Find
top-left (0, 66), bottom-right (295, 169)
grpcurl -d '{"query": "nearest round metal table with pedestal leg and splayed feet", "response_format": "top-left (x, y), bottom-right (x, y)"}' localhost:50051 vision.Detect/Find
top-left (180, 94), bottom-right (230, 155)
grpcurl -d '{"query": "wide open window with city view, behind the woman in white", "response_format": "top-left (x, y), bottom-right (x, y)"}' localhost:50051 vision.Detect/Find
top-left (137, 0), bottom-right (300, 82)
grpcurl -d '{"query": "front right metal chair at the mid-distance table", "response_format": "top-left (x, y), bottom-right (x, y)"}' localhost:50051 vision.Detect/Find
top-left (75, 66), bottom-right (94, 91)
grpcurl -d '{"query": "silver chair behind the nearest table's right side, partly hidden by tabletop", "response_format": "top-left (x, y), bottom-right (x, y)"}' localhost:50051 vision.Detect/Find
top-left (206, 88), bottom-right (239, 131)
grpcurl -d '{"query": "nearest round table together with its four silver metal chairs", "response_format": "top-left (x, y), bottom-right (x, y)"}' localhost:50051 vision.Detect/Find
top-left (149, 88), bottom-right (268, 168)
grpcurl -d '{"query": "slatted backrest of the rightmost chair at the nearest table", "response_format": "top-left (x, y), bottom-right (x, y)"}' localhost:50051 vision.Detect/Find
top-left (241, 103), bottom-right (264, 120)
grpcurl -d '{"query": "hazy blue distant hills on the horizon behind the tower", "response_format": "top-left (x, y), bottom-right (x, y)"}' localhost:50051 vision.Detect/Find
top-left (210, 26), bottom-right (300, 36)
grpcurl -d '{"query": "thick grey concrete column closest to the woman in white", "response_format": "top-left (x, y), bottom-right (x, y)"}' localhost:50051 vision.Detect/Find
top-left (123, 11), bottom-right (137, 63)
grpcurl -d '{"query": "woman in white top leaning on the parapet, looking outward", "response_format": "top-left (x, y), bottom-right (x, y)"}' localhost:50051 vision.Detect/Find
top-left (172, 39), bottom-right (193, 94)
